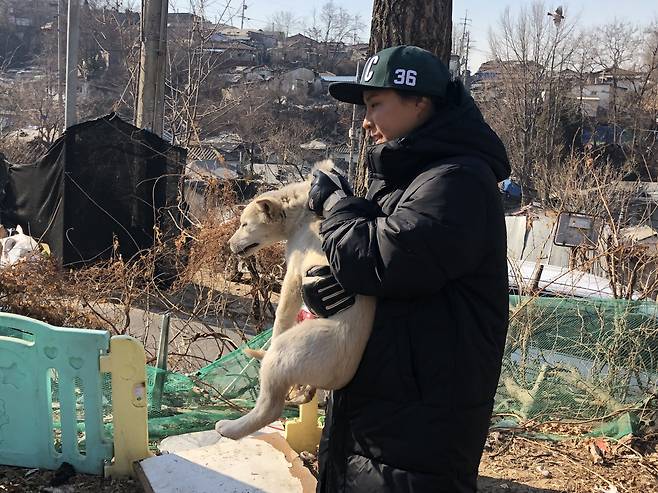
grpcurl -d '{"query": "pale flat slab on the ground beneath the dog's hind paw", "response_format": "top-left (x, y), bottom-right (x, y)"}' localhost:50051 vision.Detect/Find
top-left (136, 428), bottom-right (316, 493)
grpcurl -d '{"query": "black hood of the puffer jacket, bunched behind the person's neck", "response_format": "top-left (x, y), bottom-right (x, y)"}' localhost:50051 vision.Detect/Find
top-left (368, 81), bottom-right (510, 182)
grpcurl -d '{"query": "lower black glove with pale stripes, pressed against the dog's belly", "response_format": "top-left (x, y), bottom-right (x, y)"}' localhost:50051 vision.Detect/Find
top-left (302, 265), bottom-right (356, 318)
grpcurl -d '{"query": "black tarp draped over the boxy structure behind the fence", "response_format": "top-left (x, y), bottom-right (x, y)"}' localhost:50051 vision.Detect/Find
top-left (0, 114), bottom-right (186, 265)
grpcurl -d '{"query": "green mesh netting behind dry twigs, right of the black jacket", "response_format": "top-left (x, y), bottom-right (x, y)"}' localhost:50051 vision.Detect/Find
top-left (496, 296), bottom-right (658, 421)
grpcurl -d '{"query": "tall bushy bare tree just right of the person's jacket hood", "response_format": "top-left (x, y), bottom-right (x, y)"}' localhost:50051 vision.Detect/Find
top-left (483, 2), bottom-right (577, 200)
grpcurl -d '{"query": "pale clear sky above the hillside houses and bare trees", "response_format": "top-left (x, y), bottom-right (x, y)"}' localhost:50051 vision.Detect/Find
top-left (169, 0), bottom-right (658, 72)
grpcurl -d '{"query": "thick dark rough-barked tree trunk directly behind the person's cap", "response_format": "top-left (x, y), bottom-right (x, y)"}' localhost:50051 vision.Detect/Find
top-left (354, 0), bottom-right (452, 195)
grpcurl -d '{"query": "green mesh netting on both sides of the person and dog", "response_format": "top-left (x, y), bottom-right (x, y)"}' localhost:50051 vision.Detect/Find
top-left (93, 296), bottom-right (658, 440)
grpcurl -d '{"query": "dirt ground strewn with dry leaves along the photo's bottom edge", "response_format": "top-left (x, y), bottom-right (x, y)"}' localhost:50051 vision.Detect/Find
top-left (0, 432), bottom-right (658, 493)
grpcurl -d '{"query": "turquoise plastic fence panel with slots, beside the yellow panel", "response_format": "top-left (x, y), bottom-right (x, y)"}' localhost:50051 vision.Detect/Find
top-left (0, 313), bottom-right (112, 474)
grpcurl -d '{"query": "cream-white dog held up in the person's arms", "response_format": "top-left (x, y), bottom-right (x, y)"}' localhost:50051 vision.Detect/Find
top-left (215, 161), bottom-right (375, 440)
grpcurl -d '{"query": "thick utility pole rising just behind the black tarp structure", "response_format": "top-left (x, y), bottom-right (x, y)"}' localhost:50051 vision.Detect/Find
top-left (135, 0), bottom-right (169, 136)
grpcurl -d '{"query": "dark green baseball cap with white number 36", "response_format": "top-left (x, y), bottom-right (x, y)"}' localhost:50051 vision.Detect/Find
top-left (329, 45), bottom-right (451, 104)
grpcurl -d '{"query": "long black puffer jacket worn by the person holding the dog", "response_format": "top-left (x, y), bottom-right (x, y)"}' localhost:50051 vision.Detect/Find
top-left (318, 89), bottom-right (509, 493)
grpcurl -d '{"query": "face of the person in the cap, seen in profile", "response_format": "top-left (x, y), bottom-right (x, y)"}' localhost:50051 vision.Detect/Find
top-left (363, 89), bottom-right (432, 144)
